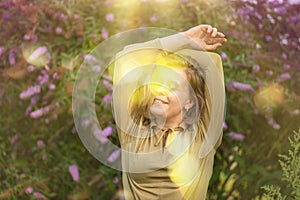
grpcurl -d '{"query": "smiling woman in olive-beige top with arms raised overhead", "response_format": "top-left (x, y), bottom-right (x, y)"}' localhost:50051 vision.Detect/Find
top-left (113, 25), bottom-right (226, 200)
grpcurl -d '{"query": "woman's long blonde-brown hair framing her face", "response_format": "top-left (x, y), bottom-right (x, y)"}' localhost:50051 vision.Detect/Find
top-left (129, 50), bottom-right (210, 140)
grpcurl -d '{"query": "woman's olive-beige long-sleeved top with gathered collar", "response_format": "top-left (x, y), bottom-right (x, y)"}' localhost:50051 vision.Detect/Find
top-left (113, 34), bottom-right (225, 200)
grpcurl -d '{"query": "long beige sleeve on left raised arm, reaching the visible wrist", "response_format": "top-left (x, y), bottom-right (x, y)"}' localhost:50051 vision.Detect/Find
top-left (109, 33), bottom-right (198, 139)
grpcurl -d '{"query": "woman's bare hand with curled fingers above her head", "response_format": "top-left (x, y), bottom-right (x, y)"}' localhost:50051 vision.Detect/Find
top-left (183, 24), bottom-right (227, 50)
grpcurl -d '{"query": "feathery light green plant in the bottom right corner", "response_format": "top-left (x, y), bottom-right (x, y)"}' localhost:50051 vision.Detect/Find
top-left (262, 129), bottom-right (300, 200)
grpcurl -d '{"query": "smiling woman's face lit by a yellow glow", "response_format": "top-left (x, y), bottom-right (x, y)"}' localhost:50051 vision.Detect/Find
top-left (150, 67), bottom-right (192, 123)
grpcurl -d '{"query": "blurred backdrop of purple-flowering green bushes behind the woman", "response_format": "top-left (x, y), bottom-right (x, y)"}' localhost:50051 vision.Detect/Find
top-left (0, 0), bottom-right (300, 200)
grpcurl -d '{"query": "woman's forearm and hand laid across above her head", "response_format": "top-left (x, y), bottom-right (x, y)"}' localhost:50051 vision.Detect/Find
top-left (110, 25), bottom-right (227, 83)
